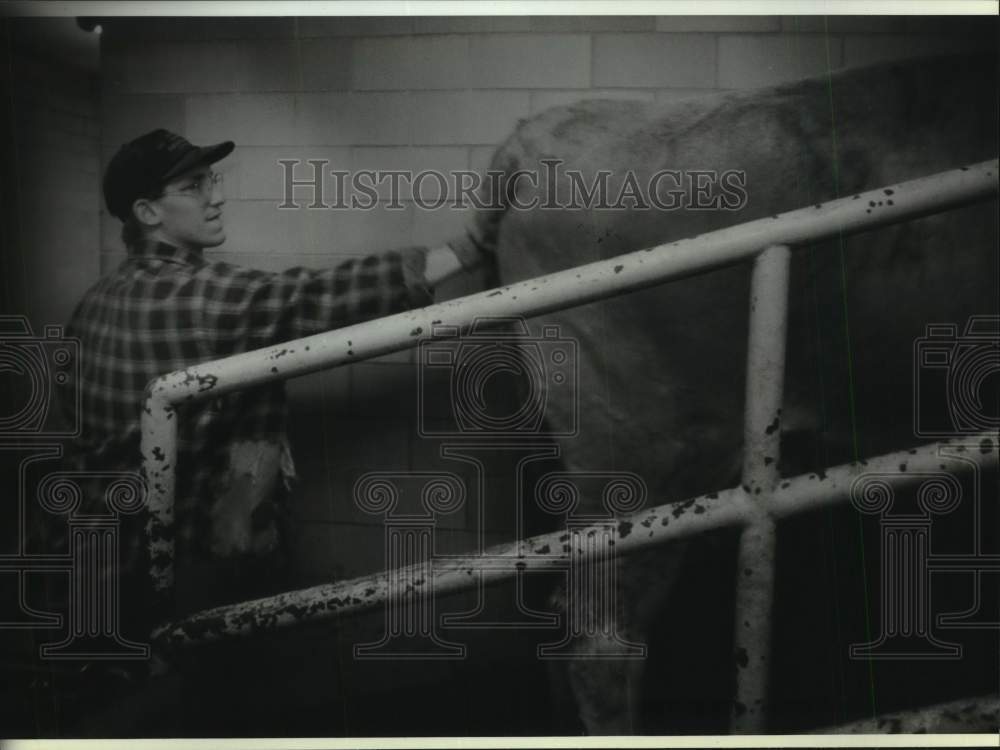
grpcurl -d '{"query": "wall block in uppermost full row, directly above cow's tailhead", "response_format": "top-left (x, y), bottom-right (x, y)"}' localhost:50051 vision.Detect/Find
top-left (469, 34), bottom-right (590, 89)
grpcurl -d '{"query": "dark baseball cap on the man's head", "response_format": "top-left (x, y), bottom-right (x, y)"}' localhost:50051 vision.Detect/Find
top-left (104, 128), bottom-right (234, 221)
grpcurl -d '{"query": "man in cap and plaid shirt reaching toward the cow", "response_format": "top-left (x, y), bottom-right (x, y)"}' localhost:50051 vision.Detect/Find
top-left (58, 130), bottom-right (499, 638)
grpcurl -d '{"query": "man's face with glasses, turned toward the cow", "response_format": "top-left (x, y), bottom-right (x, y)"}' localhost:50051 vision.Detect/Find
top-left (144, 166), bottom-right (226, 249)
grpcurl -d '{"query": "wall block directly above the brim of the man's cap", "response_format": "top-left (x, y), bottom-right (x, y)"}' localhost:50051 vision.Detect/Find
top-left (184, 94), bottom-right (301, 146)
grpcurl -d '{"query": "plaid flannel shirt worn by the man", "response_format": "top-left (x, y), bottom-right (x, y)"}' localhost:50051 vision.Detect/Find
top-left (59, 243), bottom-right (432, 574)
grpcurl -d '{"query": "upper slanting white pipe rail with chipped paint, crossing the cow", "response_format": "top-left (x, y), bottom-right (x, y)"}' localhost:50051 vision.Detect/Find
top-left (149, 159), bottom-right (998, 414)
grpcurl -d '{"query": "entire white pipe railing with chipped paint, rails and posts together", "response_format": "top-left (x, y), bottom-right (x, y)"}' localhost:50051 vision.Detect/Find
top-left (141, 159), bottom-right (998, 732)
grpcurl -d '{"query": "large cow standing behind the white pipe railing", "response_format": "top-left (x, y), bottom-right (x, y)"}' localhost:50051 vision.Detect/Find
top-left (480, 57), bottom-right (998, 734)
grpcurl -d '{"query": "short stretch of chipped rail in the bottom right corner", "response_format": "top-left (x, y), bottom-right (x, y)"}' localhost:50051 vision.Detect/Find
top-left (816, 695), bottom-right (1000, 734)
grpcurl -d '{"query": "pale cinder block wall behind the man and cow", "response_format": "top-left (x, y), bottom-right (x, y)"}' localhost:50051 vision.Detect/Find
top-left (101, 16), bottom-right (996, 582)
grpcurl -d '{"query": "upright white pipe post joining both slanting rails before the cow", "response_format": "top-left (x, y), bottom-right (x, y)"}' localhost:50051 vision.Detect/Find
top-left (731, 245), bottom-right (791, 734)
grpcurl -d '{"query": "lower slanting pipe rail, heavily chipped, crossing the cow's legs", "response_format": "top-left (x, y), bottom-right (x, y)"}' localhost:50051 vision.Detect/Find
top-left (153, 433), bottom-right (998, 649)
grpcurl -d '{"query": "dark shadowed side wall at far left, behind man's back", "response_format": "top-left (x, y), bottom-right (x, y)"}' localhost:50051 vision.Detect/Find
top-left (0, 36), bottom-right (100, 328)
